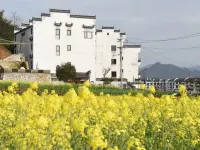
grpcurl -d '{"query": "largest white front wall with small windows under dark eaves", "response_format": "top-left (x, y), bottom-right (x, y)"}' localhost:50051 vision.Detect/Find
top-left (33, 12), bottom-right (96, 81)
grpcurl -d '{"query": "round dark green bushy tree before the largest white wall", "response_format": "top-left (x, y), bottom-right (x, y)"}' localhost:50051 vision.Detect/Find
top-left (56, 63), bottom-right (76, 82)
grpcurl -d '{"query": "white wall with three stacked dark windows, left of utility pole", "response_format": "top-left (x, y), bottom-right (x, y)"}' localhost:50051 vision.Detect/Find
top-left (96, 28), bottom-right (120, 78)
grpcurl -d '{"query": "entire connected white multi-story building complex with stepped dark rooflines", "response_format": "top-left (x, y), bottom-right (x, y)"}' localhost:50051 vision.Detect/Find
top-left (15, 9), bottom-right (141, 82)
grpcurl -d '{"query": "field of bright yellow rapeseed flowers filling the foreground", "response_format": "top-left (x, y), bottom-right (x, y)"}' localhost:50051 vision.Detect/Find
top-left (0, 83), bottom-right (200, 150)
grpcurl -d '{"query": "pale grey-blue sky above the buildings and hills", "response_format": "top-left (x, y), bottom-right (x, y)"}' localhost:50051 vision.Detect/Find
top-left (0, 0), bottom-right (200, 67)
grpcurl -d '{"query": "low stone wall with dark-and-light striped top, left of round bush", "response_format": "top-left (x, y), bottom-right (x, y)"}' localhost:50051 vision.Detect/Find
top-left (0, 69), bottom-right (51, 82)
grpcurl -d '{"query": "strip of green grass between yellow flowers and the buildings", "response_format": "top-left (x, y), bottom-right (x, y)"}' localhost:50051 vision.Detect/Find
top-left (0, 81), bottom-right (172, 97)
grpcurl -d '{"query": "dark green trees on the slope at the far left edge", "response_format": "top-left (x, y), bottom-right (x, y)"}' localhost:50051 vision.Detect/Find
top-left (0, 10), bottom-right (14, 52)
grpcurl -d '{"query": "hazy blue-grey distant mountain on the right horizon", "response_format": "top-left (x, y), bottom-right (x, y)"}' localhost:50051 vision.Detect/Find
top-left (140, 62), bottom-right (200, 79)
